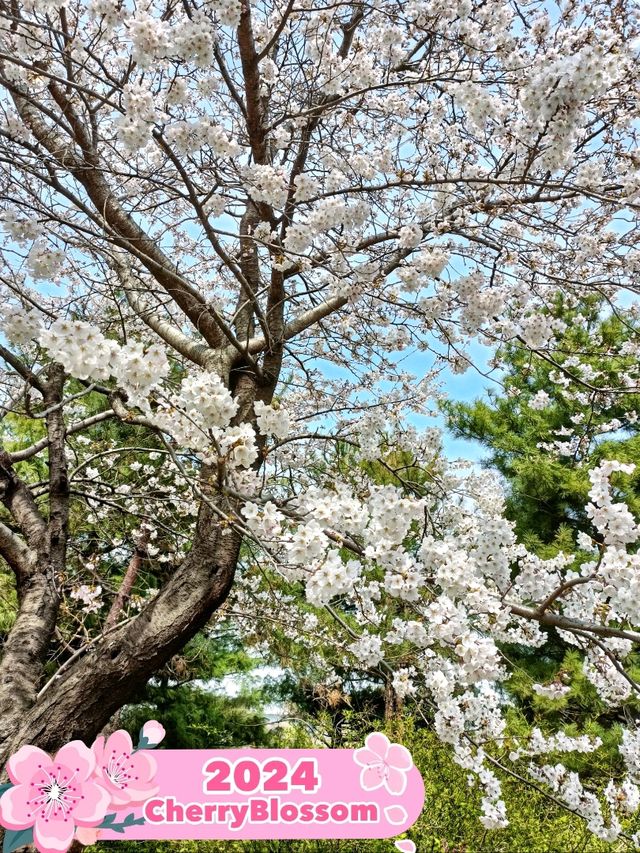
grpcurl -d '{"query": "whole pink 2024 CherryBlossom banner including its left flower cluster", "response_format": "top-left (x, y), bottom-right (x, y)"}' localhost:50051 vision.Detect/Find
top-left (0, 720), bottom-right (424, 853)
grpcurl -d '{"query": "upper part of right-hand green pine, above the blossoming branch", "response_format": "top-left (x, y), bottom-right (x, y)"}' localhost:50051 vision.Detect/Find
top-left (444, 300), bottom-right (640, 553)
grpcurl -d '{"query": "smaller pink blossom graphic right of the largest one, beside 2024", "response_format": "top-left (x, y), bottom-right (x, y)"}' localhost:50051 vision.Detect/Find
top-left (91, 729), bottom-right (159, 809)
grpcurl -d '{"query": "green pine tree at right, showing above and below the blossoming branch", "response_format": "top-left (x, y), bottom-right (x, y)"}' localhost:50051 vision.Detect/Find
top-left (444, 300), bottom-right (640, 774)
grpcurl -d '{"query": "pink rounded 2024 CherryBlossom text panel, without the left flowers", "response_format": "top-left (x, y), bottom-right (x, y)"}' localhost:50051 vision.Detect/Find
top-left (109, 736), bottom-right (424, 840)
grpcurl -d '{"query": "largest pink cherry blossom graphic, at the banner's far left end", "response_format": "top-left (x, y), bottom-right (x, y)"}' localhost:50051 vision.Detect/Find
top-left (0, 740), bottom-right (110, 853)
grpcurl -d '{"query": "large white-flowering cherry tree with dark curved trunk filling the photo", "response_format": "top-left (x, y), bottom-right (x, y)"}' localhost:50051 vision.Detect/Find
top-left (0, 0), bottom-right (640, 839)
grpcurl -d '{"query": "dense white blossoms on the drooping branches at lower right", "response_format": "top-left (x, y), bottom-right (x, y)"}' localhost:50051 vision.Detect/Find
top-left (231, 452), bottom-right (640, 839)
